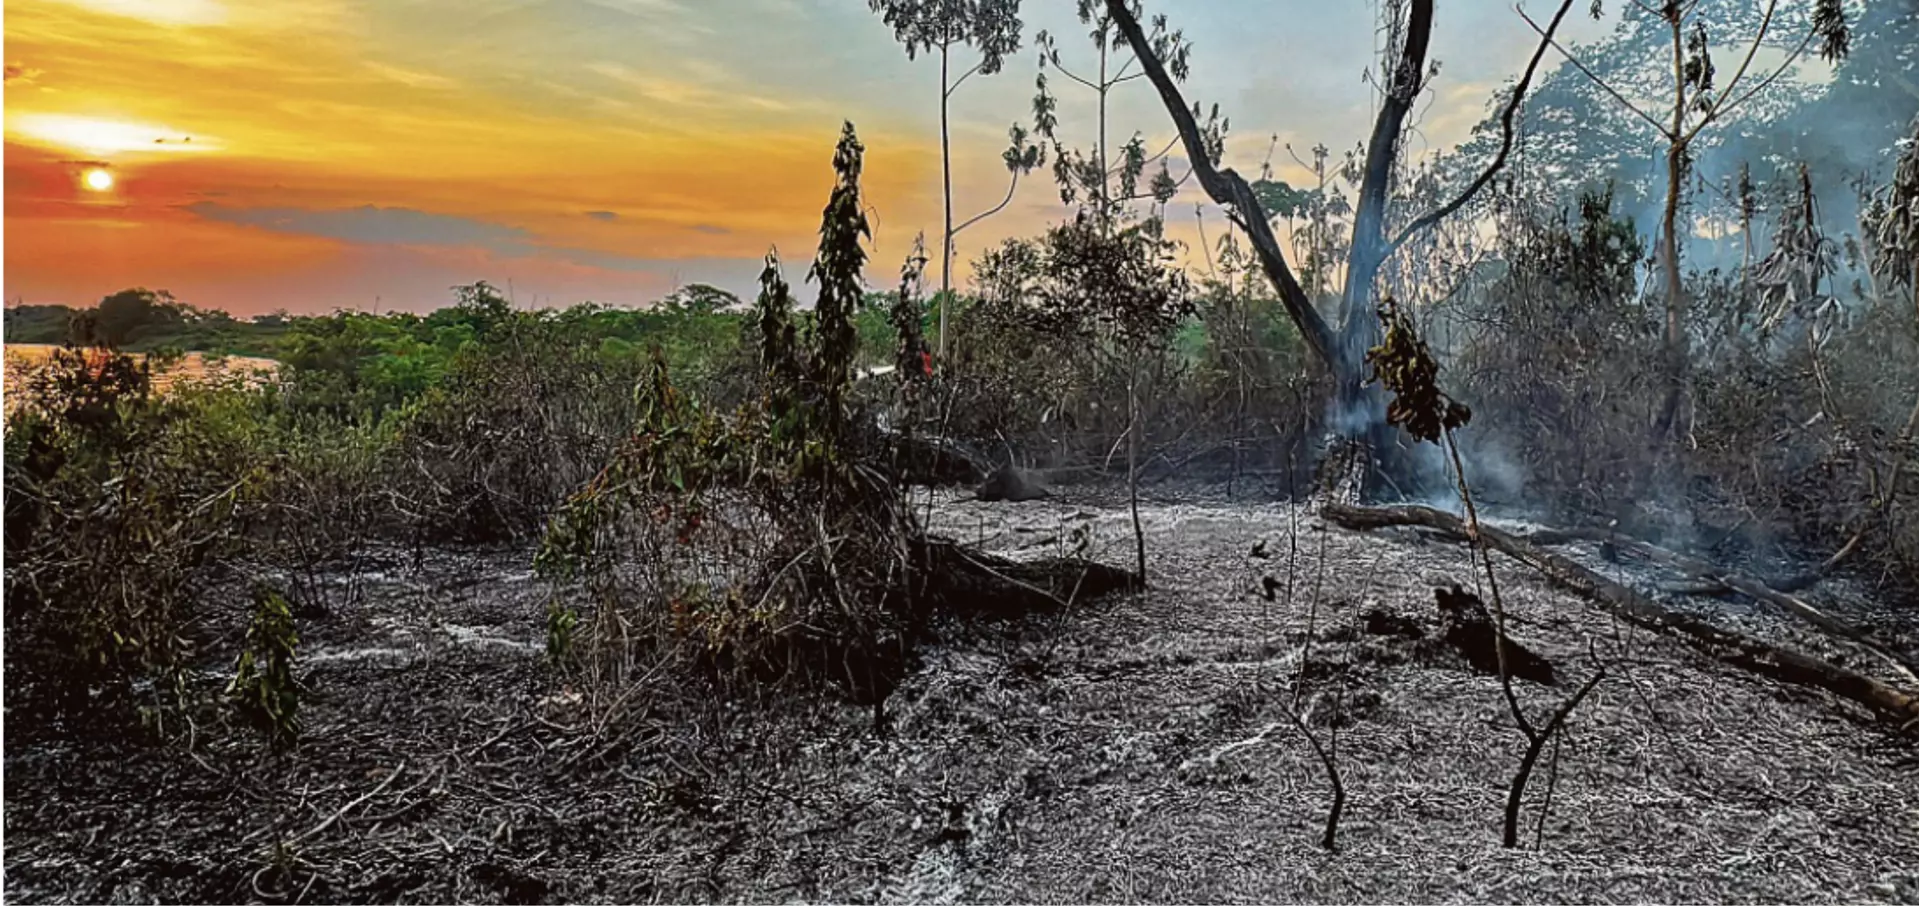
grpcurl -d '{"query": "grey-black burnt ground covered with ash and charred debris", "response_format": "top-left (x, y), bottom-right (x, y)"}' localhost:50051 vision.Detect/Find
top-left (4, 491), bottom-right (1920, 902)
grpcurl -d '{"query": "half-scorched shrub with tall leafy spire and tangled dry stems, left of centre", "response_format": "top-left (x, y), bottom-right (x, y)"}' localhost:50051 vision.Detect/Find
top-left (536, 125), bottom-right (918, 699)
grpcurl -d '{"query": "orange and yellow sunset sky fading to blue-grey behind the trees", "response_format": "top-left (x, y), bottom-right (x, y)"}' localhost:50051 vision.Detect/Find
top-left (4, 0), bottom-right (1596, 315)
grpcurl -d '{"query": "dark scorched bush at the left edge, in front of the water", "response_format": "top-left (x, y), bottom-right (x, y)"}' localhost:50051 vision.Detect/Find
top-left (6, 347), bottom-right (265, 729)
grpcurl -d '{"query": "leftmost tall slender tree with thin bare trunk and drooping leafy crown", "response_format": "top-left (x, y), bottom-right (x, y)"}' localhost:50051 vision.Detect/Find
top-left (868, 0), bottom-right (1039, 355)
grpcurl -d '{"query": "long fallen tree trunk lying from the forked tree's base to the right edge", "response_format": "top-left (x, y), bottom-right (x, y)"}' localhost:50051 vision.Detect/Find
top-left (1321, 505), bottom-right (1920, 731)
